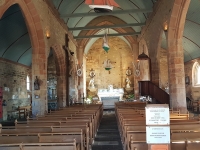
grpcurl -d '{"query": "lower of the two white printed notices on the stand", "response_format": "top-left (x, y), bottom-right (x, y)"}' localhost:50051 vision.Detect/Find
top-left (146, 126), bottom-right (170, 144)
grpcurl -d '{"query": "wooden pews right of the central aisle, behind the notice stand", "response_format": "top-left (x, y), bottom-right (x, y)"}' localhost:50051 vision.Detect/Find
top-left (115, 104), bottom-right (200, 150)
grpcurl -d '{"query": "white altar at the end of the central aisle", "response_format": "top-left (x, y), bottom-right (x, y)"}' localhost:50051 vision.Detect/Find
top-left (97, 88), bottom-right (124, 109)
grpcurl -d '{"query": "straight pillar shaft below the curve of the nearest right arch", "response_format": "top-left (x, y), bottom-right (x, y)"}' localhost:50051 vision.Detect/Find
top-left (168, 38), bottom-right (187, 112)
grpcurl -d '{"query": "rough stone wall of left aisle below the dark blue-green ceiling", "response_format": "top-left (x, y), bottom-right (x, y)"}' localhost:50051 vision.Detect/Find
top-left (0, 59), bottom-right (31, 120)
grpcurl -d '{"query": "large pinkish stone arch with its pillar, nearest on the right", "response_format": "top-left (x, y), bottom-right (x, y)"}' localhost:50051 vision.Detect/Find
top-left (167, 0), bottom-right (190, 112)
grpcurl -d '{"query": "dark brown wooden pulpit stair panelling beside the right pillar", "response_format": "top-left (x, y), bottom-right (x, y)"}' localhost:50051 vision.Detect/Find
top-left (139, 81), bottom-right (170, 104)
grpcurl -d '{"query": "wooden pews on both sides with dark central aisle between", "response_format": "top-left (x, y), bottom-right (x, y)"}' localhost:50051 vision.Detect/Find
top-left (0, 102), bottom-right (200, 150)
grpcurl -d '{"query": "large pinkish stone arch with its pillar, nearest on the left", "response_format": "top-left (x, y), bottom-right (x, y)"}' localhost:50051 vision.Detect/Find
top-left (0, 0), bottom-right (47, 115)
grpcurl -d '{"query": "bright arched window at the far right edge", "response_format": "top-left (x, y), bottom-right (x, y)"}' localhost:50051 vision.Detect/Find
top-left (192, 62), bottom-right (200, 87)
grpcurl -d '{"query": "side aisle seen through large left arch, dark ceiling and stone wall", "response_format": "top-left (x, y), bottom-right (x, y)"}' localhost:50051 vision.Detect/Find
top-left (0, 4), bottom-right (32, 120)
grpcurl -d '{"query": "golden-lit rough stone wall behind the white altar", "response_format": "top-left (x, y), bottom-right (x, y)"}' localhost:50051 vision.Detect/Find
top-left (86, 37), bottom-right (134, 96)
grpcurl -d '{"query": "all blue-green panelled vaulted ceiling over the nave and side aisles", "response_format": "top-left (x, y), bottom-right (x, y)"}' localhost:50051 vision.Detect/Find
top-left (0, 0), bottom-right (200, 66)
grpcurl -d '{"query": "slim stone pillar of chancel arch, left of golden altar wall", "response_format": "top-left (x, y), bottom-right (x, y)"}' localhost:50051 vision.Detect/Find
top-left (77, 46), bottom-right (85, 102)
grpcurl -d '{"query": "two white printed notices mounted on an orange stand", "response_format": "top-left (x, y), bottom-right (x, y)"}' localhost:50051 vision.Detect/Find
top-left (145, 104), bottom-right (170, 150)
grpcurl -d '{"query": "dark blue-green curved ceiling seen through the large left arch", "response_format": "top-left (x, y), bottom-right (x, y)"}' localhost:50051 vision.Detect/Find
top-left (0, 4), bottom-right (32, 66)
